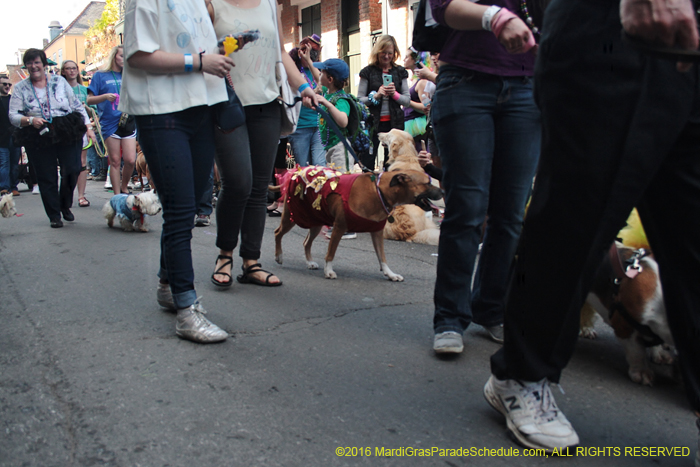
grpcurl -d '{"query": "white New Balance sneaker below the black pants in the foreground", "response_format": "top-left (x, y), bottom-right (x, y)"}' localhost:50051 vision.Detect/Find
top-left (484, 375), bottom-right (578, 450)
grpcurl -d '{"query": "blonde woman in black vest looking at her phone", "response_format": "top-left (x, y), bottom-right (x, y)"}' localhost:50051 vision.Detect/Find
top-left (357, 35), bottom-right (411, 169)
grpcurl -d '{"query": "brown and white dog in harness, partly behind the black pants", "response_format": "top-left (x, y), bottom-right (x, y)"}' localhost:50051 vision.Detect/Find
top-left (581, 243), bottom-right (674, 386)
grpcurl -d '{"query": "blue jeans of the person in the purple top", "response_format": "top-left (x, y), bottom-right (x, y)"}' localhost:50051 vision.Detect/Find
top-left (431, 66), bottom-right (541, 333)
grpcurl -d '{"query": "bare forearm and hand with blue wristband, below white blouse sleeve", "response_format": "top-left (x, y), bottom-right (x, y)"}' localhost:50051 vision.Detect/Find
top-left (127, 50), bottom-right (235, 77)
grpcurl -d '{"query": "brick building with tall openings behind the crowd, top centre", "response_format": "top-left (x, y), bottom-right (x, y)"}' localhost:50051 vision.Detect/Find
top-left (278, 0), bottom-right (418, 93)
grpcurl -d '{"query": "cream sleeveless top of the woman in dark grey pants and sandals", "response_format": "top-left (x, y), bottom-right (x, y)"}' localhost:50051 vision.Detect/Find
top-left (211, 0), bottom-right (279, 106)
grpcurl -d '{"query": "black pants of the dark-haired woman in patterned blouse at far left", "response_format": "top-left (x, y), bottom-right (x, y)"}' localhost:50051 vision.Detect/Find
top-left (25, 141), bottom-right (83, 220)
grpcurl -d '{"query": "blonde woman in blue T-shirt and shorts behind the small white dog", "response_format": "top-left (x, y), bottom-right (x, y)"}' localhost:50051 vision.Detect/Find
top-left (87, 45), bottom-right (136, 195)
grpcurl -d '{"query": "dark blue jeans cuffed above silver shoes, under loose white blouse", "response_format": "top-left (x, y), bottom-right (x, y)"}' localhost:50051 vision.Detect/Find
top-left (136, 106), bottom-right (215, 309)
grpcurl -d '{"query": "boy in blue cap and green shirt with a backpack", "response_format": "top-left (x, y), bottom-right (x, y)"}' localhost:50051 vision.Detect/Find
top-left (314, 58), bottom-right (355, 173)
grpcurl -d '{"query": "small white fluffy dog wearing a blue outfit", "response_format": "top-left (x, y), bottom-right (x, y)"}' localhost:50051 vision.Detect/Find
top-left (102, 191), bottom-right (162, 232)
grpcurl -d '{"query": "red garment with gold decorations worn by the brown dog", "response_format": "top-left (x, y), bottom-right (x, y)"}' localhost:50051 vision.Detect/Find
top-left (286, 166), bottom-right (386, 232)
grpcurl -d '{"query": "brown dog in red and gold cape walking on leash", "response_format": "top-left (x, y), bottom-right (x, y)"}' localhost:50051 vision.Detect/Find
top-left (275, 166), bottom-right (442, 281)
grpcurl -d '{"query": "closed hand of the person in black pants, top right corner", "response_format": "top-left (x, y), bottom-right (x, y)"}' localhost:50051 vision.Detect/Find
top-left (620, 0), bottom-right (699, 71)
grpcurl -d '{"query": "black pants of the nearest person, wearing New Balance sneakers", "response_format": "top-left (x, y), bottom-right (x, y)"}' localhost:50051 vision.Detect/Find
top-left (491, 0), bottom-right (700, 410)
